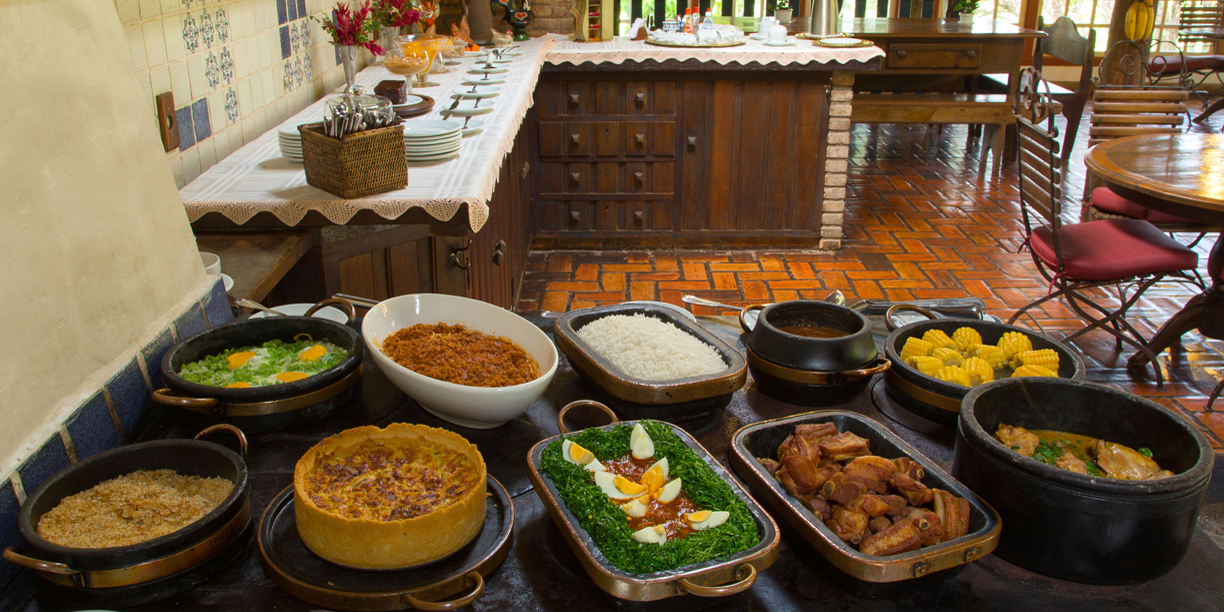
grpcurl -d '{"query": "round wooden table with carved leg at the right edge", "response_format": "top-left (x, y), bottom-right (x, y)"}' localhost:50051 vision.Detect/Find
top-left (1084, 133), bottom-right (1224, 367)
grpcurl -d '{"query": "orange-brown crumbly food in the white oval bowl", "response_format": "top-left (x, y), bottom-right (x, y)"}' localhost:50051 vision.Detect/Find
top-left (381, 323), bottom-right (540, 387)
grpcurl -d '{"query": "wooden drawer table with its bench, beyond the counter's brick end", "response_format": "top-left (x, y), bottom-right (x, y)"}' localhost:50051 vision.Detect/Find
top-left (842, 18), bottom-right (1045, 176)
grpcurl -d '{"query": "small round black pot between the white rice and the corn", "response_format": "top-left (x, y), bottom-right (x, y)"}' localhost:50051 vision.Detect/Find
top-left (739, 300), bottom-right (878, 372)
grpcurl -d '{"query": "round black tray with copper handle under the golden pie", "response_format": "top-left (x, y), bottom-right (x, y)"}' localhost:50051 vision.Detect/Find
top-left (258, 476), bottom-right (514, 611)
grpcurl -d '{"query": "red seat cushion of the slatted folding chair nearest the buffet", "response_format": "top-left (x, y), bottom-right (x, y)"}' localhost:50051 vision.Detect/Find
top-left (1029, 219), bottom-right (1198, 280)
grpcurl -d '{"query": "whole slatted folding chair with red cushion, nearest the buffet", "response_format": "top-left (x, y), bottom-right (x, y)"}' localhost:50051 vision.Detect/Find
top-left (1007, 74), bottom-right (1198, 384)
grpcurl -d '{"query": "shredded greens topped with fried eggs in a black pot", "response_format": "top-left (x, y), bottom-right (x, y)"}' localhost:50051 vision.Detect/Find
top-left (179, 337), bottom-right (349, 389)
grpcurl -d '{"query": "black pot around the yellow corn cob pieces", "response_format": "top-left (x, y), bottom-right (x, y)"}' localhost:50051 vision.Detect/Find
top-left (884, 318), bottom-right (1084, 426)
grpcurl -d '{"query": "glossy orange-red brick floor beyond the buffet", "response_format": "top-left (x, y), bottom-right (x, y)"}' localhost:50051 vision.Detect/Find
top-left (517, 102), bottom-right (1224, 452)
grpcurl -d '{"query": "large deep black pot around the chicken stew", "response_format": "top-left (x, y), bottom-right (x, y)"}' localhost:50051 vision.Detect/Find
top-left (952, 378), bottom-right (1214, 585)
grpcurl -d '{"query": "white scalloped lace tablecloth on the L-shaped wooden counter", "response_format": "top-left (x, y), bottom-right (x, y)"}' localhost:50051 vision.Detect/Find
top-left (180, 34), bottom-right (883, 231)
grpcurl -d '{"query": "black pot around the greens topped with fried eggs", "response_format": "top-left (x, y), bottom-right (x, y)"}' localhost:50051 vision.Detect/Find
top-left (153, 317), bottom-right (365, 432)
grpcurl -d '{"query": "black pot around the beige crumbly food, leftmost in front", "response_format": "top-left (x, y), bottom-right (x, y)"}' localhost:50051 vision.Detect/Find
top-left (4, 425), bottom-right (251, 596)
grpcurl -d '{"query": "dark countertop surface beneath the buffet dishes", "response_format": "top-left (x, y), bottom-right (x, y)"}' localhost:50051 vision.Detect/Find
top-left (16, 318), bottom-right (1224, 612)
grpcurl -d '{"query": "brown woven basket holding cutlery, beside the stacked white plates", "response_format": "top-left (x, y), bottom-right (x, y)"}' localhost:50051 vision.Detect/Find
top-left (297, 122), bottom-right (408, 200)
